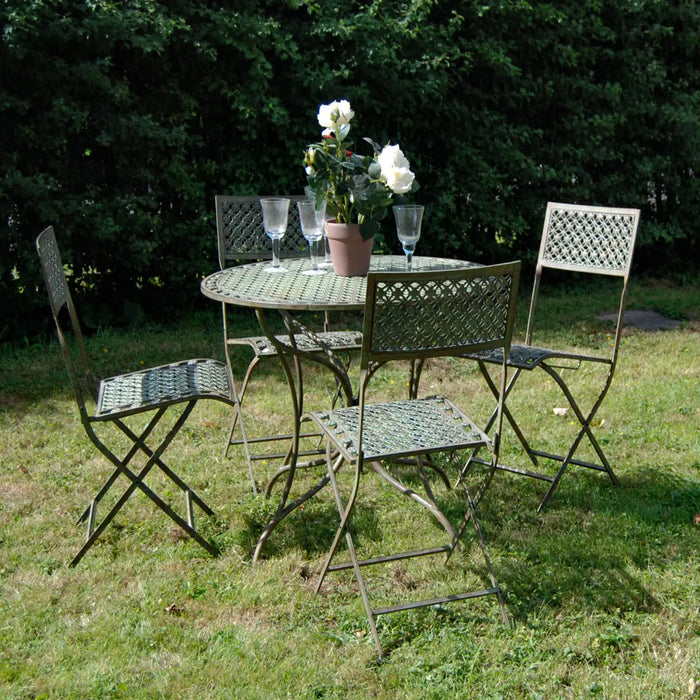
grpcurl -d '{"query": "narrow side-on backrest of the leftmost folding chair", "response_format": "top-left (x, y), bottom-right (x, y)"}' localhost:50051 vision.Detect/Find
top-left (36, 226), bottom-right (97, 420)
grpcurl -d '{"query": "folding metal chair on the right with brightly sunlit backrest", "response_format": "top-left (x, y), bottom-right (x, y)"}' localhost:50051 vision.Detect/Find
top-left (470, 202), bottom-right (639, 511)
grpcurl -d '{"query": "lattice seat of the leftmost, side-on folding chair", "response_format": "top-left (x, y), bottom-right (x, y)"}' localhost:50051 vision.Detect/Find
top-left (95, 359), bottom-right (232, 419)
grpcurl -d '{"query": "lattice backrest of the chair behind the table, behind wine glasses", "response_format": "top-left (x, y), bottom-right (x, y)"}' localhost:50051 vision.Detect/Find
top-left (214, 195), bottom-right (308, 269)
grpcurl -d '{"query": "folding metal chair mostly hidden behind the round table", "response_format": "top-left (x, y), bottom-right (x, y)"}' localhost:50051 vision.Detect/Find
top-left (215, 195), bottom-right (362, 493)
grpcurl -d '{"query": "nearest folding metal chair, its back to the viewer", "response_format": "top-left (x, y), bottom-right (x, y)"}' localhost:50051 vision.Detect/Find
top-left (305, 262), bottom-right (520, 657)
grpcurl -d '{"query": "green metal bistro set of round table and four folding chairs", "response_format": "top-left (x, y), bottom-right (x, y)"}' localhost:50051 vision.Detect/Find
top-left (37, 196), bottom-right (639, 656)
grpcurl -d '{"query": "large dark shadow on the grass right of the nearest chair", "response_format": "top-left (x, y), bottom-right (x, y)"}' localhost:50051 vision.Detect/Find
top-left (479, 466), bottom-right (700, 618)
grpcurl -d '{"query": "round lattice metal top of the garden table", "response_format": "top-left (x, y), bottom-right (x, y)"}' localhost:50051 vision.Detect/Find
top-left (200, 255), bottom-right (474, 311)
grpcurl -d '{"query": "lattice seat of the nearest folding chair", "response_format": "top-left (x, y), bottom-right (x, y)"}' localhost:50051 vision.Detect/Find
top-left (309, 396), bottom-right (491, 461)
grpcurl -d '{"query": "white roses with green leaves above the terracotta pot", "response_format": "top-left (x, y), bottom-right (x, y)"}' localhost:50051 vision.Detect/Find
top-left (304, 100), bottom-right (418, 240)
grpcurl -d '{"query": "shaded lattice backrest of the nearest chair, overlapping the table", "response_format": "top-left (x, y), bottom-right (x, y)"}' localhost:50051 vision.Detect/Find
top-left (361, 262), bottom-right (520, 371)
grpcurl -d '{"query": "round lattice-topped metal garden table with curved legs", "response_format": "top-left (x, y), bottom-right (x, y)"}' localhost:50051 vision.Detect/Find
top-left (201, 255), bottom-right (475, 561)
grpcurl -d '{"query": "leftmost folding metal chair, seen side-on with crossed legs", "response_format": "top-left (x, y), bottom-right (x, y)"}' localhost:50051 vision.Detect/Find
top-left (36, 226), bottom-right (235, 566)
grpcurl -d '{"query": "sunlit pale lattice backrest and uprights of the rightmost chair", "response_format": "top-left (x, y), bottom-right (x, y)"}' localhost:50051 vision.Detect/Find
top-left (525, 202), bottom-right (639, 352)
